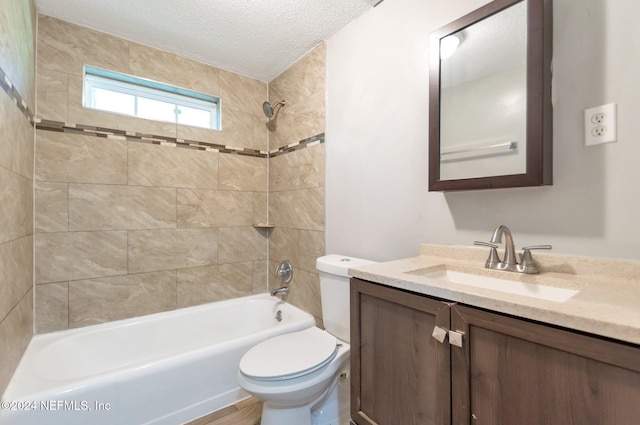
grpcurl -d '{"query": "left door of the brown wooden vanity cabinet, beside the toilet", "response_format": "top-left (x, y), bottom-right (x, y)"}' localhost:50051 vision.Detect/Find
top-left (351, 279), bottom-right (451, 425)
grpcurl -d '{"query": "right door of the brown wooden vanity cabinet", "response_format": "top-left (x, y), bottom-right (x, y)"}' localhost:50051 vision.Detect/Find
top-left (451, 305), bottom-right (640, 425)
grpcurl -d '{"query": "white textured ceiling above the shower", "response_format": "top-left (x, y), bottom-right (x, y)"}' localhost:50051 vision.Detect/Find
top-left (36, 0), bottom-right (380, 82)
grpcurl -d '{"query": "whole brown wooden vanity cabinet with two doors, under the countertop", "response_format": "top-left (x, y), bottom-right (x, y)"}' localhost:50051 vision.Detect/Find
top-left (351, 279), bottom-right (640, 425)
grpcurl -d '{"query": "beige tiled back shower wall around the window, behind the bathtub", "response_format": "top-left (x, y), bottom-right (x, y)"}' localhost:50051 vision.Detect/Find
top-left (35, 16), bottom-right (268, 332)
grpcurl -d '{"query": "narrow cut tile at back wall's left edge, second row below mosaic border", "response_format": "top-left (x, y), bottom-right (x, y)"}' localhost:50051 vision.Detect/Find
top-left (34, 182), bottom-right (69, 232)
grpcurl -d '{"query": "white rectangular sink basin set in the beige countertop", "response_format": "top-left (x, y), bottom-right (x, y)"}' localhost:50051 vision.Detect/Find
top-left (408, 265), bottom-right (579, 303)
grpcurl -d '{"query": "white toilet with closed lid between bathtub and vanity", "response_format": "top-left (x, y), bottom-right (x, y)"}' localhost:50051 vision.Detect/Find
top-left (238, 255), bottom-right (373, 425)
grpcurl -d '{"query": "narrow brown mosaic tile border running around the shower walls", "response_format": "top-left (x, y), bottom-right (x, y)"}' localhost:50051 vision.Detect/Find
top-left (0, 64), bottom-right (324, 158)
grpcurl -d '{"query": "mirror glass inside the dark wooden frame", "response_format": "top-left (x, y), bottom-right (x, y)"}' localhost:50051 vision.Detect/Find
top-left (440, 1), bottom-right (527, 180)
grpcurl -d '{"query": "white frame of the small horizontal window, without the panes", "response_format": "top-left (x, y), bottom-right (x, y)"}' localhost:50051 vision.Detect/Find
top-left (82, 65), bottom-right (220, 130)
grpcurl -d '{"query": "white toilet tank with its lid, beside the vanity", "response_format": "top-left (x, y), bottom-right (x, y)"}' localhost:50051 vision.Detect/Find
top-left (316, 254), bottom-right (375, 342)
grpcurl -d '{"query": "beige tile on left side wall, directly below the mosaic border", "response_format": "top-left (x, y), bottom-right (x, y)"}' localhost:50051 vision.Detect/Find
top-left (0, 90), bottom-right (33, 179)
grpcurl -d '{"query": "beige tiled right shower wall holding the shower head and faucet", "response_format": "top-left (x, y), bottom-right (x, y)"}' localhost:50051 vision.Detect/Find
top-left (269, 43), bottom-right (326, 319)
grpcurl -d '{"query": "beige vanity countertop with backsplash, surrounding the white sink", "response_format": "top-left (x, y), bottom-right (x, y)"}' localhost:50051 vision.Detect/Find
top-left (349, 245), bottom-right (640, 344)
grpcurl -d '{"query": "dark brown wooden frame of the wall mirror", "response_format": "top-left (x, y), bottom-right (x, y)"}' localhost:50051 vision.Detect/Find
top-left (429, 0), bottom-right (553, 192)
